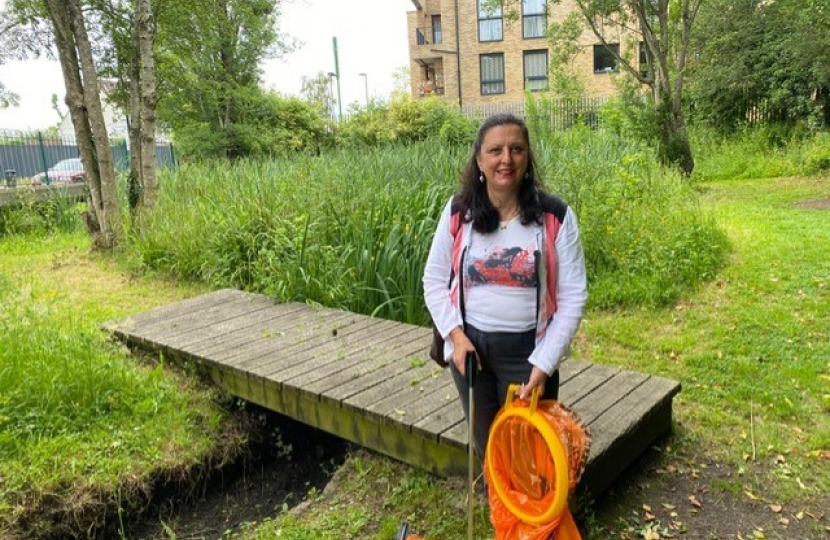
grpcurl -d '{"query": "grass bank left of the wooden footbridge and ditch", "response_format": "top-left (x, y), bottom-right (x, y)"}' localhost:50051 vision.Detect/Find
top-left (0, 233), bottom-right (242, 538)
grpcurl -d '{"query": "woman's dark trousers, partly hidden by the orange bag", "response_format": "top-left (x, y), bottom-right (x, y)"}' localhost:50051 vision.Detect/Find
top-left (450, 324), bottom-right (559, 461)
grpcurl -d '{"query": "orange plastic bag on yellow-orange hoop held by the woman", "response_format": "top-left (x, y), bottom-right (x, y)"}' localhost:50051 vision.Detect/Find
top-left (484, 392), bottom-right (591, 540)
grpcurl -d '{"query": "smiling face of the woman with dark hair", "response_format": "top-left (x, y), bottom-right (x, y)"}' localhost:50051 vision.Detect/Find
top-left (476, 124), bottom-right (529, 197)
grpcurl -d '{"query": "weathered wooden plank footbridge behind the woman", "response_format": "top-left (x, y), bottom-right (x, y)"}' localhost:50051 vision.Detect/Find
top-left (104, 289), bottom-right (680, 495)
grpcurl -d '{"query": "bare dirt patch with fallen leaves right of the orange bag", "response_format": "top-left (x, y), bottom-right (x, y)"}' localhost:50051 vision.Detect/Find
top-left (587, 438), bottom-right (830, 540)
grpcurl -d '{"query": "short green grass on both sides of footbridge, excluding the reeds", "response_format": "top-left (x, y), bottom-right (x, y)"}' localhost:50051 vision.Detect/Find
top-left (0, 178), bottom-right (830, 540)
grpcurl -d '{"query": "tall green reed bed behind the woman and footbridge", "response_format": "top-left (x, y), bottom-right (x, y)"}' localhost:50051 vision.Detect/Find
top-left (130, 130), bottom-right (726, 324)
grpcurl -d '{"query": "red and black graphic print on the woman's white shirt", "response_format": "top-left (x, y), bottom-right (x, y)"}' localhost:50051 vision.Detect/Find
top-left (467, 246), bottom-right (537, 287)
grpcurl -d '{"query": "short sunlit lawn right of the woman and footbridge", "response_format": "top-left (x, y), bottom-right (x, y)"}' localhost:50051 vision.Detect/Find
top-left (584, 174), bottom-right (830, 498)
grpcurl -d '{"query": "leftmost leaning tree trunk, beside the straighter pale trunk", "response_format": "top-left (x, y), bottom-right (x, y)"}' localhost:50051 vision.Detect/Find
top-left (45, 0), bottom-right (123, 249)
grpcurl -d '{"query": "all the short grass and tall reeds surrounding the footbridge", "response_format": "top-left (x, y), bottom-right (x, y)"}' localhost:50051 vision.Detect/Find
top-left (0, 127), bottom-right (830, 540)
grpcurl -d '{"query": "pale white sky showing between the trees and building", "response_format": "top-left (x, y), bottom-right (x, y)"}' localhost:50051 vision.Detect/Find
top-left (0, 0), bottom-right (415, 130)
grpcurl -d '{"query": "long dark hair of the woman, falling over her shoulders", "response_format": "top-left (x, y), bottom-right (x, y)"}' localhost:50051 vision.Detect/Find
top-left (454, 113), bottom-right (542, 233)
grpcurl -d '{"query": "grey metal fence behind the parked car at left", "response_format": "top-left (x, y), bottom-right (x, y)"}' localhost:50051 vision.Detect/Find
top-left (0, 130), bottom-right (176, 183)
